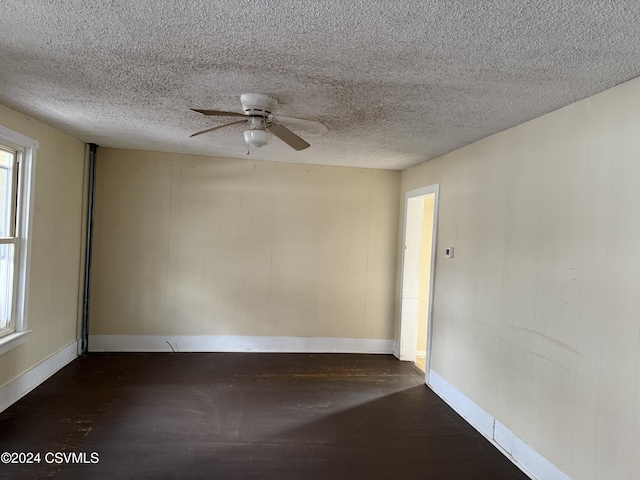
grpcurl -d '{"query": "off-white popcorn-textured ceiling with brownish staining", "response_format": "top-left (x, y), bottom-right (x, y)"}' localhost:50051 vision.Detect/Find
top-left (0, 0), bottom-right (640, 169)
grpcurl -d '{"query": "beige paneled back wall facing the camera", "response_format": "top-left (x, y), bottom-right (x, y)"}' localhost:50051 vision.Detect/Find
top-left (90, 149), bottom-right (400, 339)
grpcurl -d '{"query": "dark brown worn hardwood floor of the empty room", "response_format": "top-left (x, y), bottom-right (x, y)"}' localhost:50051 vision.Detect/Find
top-left (0, 353), bottom-right (527, 480)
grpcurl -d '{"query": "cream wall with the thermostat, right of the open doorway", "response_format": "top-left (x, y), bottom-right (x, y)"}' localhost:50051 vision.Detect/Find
top-left (401, 80), bottom-right (640, 479)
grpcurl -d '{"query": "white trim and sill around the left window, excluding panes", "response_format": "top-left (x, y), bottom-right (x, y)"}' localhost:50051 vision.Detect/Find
top-left (0, 125), bottom-right (40, 355)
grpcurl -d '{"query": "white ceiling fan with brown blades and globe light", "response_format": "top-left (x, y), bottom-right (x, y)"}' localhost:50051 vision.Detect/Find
top-left (191, 93), bottom-right (329, 150)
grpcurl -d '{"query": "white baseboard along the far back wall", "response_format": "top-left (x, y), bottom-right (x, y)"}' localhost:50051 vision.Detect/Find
top-left (89, 335), bottom-right (393, 354)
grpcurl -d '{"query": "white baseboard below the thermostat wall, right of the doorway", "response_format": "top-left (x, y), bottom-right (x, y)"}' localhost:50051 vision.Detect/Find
top-left (429, 370), bottom-right (571, 480)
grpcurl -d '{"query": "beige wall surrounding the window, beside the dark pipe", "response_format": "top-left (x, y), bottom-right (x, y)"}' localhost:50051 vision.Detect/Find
top-left (0, 105), bottom-right (85, 386)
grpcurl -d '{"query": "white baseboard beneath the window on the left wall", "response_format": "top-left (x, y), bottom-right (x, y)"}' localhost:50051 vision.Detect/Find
top-left (0, 341), bottom-right (79, 412)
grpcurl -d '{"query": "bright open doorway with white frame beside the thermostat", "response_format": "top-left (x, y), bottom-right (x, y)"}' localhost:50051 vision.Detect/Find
top-left (399, 184), bottom-right (439, 383)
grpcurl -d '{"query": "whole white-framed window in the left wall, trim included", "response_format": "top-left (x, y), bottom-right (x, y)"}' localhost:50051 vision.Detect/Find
top-left (0, 126), bottom-right (38, 354)
